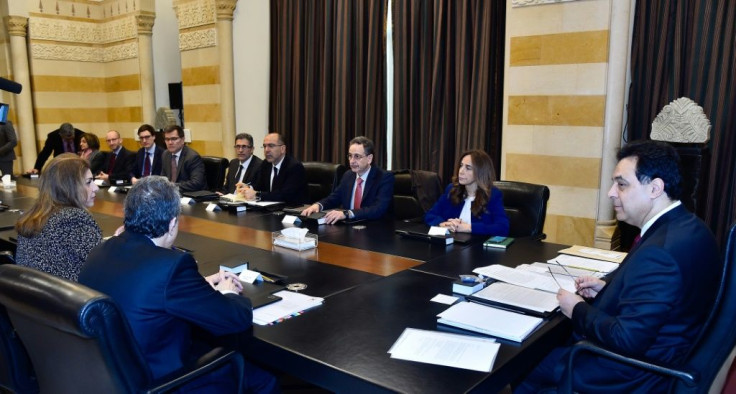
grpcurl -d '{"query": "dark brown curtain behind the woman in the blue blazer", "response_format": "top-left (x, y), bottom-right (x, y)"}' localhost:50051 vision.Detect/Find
top-left (391, 0), bottom-right (506, 183)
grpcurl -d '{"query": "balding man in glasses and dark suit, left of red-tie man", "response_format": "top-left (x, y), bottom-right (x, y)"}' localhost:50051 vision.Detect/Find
top-left (239, 133), bottom-right (307, 205)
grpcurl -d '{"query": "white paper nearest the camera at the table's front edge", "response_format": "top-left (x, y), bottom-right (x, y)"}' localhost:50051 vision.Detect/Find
top-left (388, 328), bottom-right (501, 372)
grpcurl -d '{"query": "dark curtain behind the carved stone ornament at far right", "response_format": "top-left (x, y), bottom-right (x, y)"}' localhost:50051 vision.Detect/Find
top-left (625, 0), bottom-right (736, 245)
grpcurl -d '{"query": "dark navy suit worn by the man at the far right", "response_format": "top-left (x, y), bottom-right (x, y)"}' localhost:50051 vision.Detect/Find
top-left (558, 206), bottom-right (723, 392)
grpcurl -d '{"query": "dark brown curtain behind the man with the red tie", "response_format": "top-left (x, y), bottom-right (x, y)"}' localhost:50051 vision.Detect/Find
top-left (269, 0), bottom-right (387, 166)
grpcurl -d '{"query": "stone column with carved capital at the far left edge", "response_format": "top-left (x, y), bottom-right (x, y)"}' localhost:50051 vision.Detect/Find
top-left (5, 15), bottom-right (38, 172)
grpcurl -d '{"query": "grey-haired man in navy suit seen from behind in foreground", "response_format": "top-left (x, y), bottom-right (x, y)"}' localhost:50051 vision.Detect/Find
top-left (79, 176), bottom-right (276, 393)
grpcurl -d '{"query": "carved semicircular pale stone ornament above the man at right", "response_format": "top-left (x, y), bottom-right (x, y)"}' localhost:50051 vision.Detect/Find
top-left (650, 97), bottom-right (711, 143)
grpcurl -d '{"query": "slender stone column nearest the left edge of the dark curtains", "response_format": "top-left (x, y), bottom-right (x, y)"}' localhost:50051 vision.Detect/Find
top-left (215, 0), bottom-right (238, 158)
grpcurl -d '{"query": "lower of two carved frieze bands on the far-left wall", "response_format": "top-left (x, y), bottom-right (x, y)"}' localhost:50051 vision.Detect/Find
top-left (31, 42), bottom-right (138, 63)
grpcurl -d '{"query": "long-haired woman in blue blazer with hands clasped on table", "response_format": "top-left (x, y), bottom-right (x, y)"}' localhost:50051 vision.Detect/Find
top-left (424, 150), bottom-right (509, 236)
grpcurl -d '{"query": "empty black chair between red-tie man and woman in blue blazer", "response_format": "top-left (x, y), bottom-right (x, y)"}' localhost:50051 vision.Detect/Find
top-left (392, 170), bottom-right (442, 221)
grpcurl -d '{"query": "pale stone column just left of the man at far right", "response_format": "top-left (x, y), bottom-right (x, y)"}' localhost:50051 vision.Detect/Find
top-left (594, 0), bottom-right (631, 250)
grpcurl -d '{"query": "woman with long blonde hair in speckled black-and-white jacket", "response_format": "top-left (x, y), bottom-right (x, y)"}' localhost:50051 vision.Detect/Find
top-left (15, 153), bottom-right (102, 281)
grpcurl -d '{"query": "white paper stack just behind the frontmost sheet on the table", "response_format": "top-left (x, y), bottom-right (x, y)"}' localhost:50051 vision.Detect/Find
top-left (437, 302), bottom-right (543, 342)
